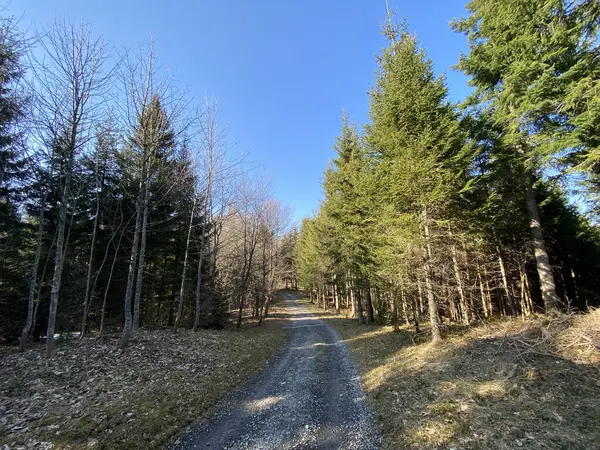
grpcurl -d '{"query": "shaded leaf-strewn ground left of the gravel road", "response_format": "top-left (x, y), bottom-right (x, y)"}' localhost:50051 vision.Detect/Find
top-left (0, 307), bottom-right (289, 450)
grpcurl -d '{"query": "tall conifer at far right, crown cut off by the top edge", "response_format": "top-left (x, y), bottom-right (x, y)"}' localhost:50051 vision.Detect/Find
top-left (453, 0), bottom-right (599, 311)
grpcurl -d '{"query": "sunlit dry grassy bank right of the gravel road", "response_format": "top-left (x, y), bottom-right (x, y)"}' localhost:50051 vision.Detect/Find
top-left (305, 300), bottom-right (600, 450)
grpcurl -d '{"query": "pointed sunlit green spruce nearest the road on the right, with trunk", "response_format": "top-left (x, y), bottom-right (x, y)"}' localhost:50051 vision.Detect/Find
top-left (366, 23), bottom-right (462, 342)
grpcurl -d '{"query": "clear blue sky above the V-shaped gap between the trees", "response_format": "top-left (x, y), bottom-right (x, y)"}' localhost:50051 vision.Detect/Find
top-left (7, 0), bottom-right (468, 224)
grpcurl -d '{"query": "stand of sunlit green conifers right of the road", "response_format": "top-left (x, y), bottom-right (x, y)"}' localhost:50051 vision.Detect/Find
top-left (296, 0), bottom-right (600, 342)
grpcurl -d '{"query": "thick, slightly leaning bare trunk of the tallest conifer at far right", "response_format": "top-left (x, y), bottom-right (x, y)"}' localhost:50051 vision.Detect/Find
top-left (525, 174), bottom-right (558, 313)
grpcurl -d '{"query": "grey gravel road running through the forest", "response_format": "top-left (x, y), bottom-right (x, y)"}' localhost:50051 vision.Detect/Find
top-left (168, 292), bottom-right (379, 450)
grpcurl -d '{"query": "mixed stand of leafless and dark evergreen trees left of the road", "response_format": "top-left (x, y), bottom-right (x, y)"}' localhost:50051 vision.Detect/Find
top-left (0, 17), bottom-right (293, 357)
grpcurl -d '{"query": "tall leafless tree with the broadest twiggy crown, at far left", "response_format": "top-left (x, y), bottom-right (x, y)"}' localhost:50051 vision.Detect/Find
top-left (32, 22), bottom-right (112, 357)
